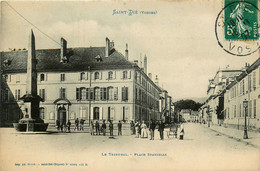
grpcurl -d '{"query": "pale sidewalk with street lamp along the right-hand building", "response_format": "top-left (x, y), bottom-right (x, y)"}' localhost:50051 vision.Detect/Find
top-left (203, 125), bottom-right (260, 148)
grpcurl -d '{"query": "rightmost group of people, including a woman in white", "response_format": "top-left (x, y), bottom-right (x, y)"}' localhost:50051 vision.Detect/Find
top-left (130, 120), bottom-right (184, 140)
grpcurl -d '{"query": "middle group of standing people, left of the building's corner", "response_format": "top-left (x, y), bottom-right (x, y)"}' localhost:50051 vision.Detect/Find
top-left (90, 120), bottom-right (122, 136)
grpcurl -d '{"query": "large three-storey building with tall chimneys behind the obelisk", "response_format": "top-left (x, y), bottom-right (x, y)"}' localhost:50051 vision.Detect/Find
top-left (0, 35), bottom-right (161, 126)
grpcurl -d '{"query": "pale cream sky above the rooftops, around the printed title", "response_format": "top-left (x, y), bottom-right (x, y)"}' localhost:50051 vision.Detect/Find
top-left (0, 0), bottom-right (259, 99)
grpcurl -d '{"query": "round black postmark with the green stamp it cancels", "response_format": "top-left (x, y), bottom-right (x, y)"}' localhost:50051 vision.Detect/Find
top-left (215, 0), bottom-right (260, 56)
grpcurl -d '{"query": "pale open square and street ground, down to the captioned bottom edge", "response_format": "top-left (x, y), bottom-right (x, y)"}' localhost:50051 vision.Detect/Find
top-left (0, 123), bottom-right (260, 170)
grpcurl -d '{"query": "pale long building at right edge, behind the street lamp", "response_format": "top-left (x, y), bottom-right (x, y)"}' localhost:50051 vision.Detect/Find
top-left (223, 58), bottom-right (260, 131)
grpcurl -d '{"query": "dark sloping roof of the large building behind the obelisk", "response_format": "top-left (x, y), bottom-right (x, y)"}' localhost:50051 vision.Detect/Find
top-left (0, 47), bottom-right (134, 73)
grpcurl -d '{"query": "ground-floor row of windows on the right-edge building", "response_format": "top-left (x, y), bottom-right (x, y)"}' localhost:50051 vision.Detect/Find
top-left (225, 99), bottom-right (256, 119)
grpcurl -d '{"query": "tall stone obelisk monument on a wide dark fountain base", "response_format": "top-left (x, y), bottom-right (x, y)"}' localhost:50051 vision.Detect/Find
top-left (13, 30), bottom-right (48, 132)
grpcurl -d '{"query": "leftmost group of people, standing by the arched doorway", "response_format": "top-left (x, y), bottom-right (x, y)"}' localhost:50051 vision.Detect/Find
top-left (56, 118), bottom-right (85, 132)
